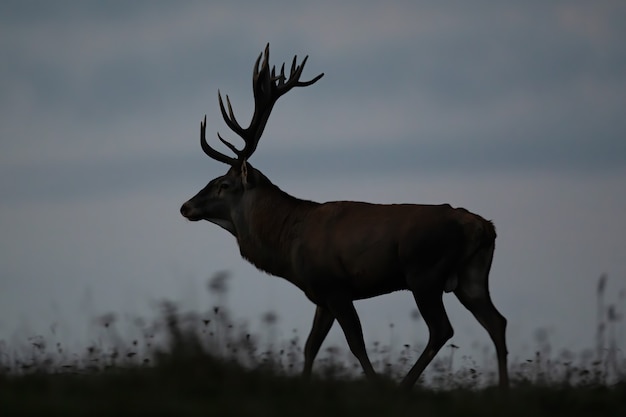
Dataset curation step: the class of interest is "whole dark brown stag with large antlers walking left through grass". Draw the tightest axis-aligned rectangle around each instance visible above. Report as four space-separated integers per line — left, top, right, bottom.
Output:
180 43 509 389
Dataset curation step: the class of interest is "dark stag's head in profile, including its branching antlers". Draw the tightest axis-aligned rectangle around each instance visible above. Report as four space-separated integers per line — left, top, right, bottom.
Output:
180 44 324 237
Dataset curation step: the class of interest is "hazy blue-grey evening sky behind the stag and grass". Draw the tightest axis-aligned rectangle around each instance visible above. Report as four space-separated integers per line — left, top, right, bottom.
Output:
0 0 626 374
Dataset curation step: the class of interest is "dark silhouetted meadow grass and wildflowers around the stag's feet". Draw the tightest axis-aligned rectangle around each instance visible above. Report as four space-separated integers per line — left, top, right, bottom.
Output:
0 276 626 416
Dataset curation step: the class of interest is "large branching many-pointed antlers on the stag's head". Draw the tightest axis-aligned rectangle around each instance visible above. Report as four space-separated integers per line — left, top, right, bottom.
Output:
200 43 324 168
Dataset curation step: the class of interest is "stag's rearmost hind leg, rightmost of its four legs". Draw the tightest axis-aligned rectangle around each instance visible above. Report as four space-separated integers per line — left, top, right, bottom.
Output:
454 245 509 387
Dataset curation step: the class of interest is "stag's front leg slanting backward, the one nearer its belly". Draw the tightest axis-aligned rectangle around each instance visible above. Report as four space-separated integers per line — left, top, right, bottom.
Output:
327 298 376 378
